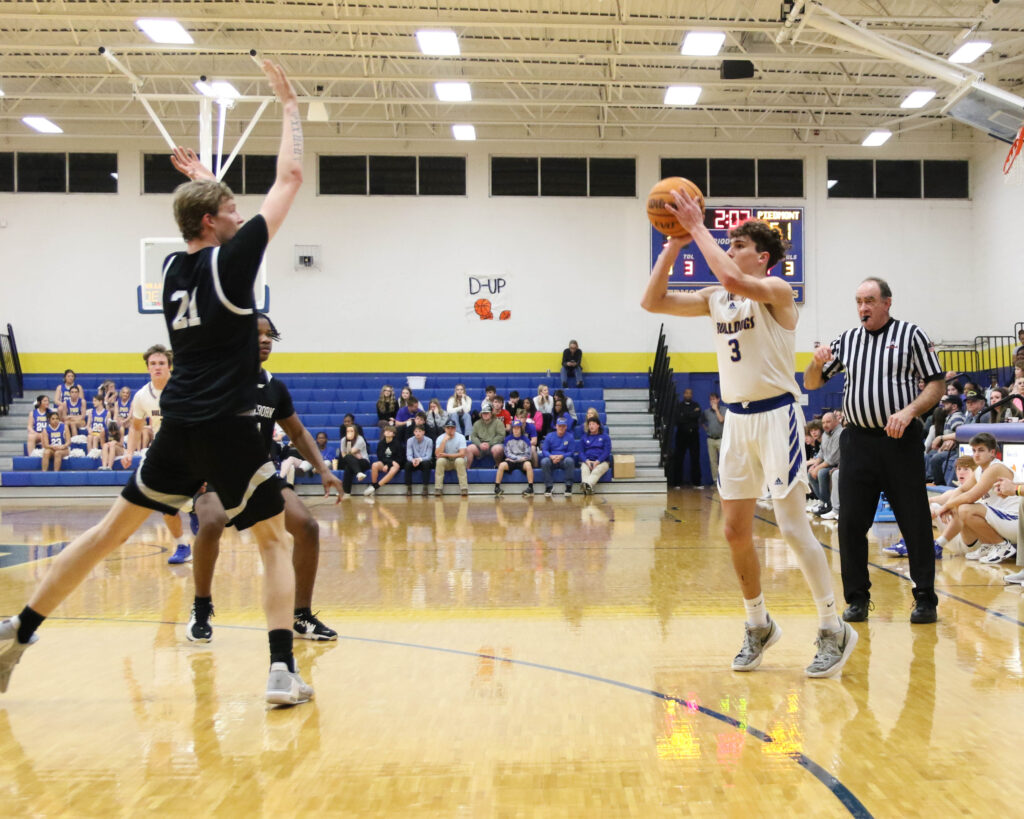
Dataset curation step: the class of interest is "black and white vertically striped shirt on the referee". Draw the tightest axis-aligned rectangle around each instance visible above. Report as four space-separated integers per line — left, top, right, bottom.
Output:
821 318 943 429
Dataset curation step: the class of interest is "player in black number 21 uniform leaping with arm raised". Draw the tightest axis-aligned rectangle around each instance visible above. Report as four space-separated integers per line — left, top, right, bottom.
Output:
0 60 313 704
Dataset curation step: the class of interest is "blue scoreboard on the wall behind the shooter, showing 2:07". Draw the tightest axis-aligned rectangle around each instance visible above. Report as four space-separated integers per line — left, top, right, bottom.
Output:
650 205 805 304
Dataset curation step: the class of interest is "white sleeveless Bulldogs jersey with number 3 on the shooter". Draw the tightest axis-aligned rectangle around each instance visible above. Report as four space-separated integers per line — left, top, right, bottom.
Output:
708 288 800 403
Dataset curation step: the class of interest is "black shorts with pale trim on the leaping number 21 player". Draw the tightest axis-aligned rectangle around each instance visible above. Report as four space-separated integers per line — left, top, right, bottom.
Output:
121 416 285 529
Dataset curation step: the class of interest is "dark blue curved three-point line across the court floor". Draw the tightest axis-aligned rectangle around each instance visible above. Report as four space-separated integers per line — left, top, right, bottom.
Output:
50 616 872 819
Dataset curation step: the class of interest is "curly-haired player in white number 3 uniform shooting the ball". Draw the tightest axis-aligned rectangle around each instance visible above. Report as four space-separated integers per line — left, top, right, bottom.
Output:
641 185 857 677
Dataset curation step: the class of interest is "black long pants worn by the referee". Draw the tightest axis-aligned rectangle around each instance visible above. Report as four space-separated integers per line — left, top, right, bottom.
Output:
839 421 938 605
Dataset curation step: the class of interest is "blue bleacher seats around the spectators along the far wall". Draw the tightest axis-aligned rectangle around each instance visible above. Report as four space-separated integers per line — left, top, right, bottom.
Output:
2 371 647 488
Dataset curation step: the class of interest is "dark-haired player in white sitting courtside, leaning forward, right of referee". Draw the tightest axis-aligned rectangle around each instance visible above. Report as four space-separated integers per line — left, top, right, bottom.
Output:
932 432 1020 563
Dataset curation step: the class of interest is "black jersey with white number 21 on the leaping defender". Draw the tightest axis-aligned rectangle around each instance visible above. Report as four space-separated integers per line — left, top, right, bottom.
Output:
160 216 268 424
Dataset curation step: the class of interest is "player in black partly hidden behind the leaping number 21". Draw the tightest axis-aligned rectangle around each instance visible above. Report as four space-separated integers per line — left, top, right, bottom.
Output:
185 314 342 643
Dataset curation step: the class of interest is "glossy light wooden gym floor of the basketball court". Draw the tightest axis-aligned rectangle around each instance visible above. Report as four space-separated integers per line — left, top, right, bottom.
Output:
0 490 1024 817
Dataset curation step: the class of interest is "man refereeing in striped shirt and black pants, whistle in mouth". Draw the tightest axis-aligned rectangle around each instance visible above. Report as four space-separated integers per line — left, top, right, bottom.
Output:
804 276 944 622
